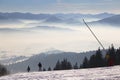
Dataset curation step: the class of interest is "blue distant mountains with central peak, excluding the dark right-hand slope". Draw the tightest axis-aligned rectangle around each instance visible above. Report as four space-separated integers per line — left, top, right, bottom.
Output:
0 12 114 24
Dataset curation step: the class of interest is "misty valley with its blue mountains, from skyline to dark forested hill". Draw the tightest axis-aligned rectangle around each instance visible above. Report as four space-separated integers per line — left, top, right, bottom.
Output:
0 13 120 58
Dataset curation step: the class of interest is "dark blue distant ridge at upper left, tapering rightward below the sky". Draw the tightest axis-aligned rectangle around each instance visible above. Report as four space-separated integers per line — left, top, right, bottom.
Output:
0 12 51 20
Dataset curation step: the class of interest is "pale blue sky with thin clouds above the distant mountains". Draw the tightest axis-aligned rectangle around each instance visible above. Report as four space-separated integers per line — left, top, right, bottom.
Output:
0 0 120 14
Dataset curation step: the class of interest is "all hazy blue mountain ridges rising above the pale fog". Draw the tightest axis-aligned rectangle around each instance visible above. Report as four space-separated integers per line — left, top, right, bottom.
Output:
0 12 120 32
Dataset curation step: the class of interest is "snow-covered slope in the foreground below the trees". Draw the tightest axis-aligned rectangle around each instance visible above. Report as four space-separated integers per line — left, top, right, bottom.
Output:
0 66 120 80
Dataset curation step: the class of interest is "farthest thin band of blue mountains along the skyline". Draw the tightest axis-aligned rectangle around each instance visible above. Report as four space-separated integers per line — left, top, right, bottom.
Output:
0 12 114 20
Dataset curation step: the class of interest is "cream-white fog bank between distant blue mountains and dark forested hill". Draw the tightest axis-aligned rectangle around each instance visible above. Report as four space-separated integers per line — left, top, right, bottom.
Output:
0 20 120 57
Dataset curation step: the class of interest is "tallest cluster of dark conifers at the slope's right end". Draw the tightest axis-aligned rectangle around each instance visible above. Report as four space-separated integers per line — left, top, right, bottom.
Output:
80 45 120 68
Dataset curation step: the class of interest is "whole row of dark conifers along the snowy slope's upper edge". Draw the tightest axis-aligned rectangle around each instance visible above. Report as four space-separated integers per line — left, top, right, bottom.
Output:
28 45 120 72
